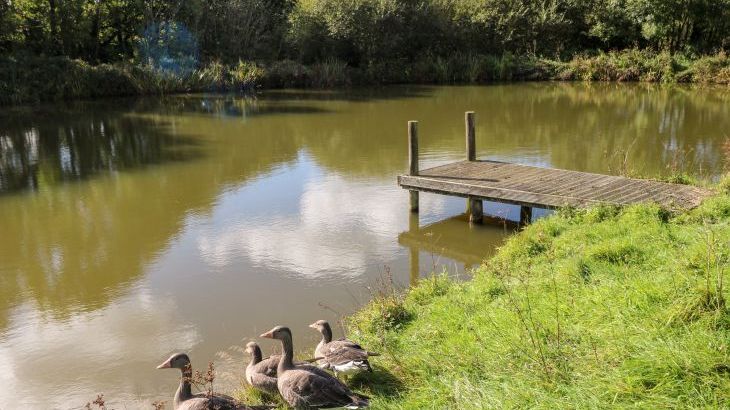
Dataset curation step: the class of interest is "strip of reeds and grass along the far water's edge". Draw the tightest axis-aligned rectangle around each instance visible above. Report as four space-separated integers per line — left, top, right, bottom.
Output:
0 50 730 105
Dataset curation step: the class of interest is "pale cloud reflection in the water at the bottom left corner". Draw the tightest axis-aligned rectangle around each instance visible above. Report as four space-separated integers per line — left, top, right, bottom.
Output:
0 289 200 409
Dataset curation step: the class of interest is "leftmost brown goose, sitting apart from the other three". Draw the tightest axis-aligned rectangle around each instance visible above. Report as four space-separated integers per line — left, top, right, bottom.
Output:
157 353 270 410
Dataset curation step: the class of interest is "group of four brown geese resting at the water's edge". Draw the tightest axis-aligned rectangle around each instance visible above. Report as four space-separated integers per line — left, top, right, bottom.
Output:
157 320 378 410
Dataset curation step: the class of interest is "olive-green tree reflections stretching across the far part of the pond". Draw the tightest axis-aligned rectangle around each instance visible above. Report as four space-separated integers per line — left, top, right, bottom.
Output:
0 84 730 328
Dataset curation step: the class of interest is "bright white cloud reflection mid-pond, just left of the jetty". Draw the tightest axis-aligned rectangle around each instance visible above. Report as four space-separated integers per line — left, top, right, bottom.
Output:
197 167 444 278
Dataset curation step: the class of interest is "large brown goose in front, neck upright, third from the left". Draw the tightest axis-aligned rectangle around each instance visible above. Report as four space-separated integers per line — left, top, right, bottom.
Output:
261 326 368 409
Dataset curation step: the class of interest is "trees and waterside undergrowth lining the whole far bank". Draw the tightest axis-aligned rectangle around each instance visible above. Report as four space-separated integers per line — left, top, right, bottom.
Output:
0 0 730 104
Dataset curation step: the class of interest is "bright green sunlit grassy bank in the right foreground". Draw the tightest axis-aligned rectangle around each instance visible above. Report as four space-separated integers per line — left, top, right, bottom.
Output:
342 179 730 409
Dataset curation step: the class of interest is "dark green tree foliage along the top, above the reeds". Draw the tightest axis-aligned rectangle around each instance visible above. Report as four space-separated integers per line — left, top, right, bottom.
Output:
0 0 730 67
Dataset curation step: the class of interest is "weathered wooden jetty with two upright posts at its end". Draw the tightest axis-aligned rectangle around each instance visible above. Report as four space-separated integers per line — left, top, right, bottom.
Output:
398 112 711 224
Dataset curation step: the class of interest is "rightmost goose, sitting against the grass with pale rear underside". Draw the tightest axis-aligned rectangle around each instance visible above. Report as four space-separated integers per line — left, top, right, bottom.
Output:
309 320 379 376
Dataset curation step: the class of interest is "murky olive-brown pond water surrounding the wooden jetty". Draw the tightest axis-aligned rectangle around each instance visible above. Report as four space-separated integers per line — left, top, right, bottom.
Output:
0 83 730 409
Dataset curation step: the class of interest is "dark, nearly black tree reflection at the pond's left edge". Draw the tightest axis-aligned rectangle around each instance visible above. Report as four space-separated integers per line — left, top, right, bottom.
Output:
0 108 199 193
